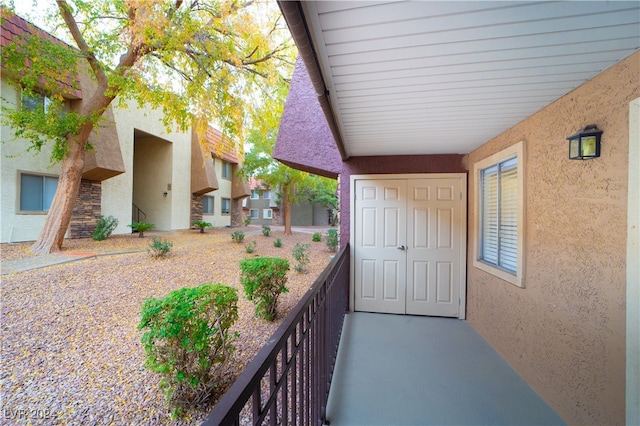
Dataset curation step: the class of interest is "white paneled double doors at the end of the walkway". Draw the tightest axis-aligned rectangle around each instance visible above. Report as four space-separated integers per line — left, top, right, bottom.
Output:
352 175 466 318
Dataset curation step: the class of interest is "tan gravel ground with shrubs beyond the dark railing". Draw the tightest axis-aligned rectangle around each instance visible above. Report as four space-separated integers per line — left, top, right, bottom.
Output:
0 227 333 425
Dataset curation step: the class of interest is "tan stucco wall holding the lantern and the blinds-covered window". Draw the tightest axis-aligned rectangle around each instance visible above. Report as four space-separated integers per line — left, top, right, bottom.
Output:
467 52 640 424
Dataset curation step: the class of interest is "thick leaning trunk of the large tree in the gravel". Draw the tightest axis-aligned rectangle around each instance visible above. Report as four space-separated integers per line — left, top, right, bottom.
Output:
31 129 91 254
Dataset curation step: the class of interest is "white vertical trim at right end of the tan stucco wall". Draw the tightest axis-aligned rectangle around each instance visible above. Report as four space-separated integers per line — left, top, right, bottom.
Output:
626 98 640 425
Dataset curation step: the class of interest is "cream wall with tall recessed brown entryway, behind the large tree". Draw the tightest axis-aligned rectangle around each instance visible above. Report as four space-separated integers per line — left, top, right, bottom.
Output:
102 102 191 234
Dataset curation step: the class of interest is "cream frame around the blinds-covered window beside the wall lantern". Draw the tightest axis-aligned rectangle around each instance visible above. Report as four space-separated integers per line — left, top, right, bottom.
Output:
473 141 526 288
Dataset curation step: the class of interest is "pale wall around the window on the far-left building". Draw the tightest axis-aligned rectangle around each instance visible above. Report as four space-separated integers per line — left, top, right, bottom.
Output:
0 74 60 243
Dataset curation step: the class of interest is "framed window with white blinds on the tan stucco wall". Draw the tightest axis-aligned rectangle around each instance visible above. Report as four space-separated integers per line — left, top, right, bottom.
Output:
474 142 524 287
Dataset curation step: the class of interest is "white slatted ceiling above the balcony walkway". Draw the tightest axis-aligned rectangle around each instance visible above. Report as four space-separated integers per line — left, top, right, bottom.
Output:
296 1 640 156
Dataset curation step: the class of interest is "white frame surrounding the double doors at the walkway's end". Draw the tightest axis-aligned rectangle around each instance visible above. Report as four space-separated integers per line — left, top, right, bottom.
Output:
349 173 468 319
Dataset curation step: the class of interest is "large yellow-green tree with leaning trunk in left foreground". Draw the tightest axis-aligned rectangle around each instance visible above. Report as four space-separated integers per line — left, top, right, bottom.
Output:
2 0 292 254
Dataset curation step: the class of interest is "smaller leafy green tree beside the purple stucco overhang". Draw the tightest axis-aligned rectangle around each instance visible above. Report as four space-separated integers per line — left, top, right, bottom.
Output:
240 80 338 235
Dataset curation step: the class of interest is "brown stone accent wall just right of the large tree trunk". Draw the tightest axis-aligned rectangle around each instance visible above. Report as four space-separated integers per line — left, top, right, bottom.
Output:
69 179 102 238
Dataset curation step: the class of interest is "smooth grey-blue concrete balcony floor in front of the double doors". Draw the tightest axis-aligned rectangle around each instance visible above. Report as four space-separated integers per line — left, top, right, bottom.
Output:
327 312 564 426
